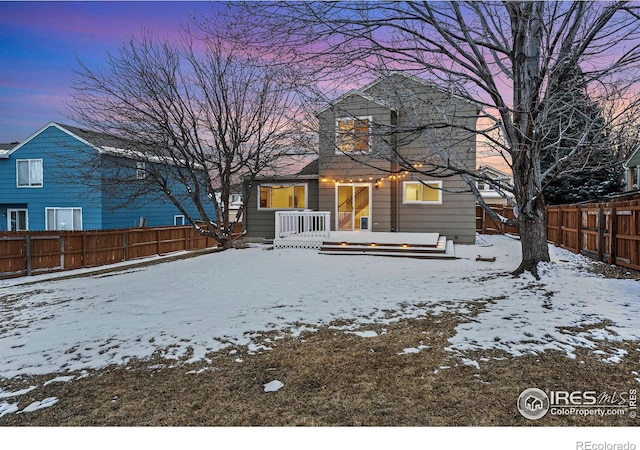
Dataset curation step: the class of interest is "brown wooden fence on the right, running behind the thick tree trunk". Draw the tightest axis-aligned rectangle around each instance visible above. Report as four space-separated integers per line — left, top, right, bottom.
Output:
476 199 640 270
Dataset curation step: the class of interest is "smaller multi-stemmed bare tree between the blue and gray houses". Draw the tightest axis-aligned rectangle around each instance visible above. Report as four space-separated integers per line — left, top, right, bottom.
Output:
68 22 308 248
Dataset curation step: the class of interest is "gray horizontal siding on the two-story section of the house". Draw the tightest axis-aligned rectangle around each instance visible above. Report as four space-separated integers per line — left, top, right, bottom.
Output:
318 75 477 243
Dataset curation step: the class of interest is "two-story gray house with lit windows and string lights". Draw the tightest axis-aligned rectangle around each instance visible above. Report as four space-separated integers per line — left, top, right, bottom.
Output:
244 72 478 243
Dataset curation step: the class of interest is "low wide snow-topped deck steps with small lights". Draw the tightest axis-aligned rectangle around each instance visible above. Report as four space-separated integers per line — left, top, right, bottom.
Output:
320 232 455 259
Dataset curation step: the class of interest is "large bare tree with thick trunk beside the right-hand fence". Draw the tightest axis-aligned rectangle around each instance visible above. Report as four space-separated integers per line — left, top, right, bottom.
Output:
238 1 640 274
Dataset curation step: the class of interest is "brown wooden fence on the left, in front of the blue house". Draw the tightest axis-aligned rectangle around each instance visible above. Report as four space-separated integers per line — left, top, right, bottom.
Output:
0 226 230 278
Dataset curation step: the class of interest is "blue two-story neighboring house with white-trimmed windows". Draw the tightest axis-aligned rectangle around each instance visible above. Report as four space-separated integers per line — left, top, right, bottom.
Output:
0 122 215 231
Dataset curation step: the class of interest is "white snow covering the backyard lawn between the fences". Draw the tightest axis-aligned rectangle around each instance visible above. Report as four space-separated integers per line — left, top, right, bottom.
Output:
0 236 640 415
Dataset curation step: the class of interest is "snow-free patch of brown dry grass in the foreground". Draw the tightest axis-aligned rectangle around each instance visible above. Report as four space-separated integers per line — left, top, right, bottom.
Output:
0 305 640 426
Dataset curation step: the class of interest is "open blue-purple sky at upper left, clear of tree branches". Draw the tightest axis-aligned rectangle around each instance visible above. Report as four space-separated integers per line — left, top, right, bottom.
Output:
0 1 215 143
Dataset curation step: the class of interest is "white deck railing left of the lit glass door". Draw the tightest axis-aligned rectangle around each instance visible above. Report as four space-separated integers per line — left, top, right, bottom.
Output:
274 211 331 248
